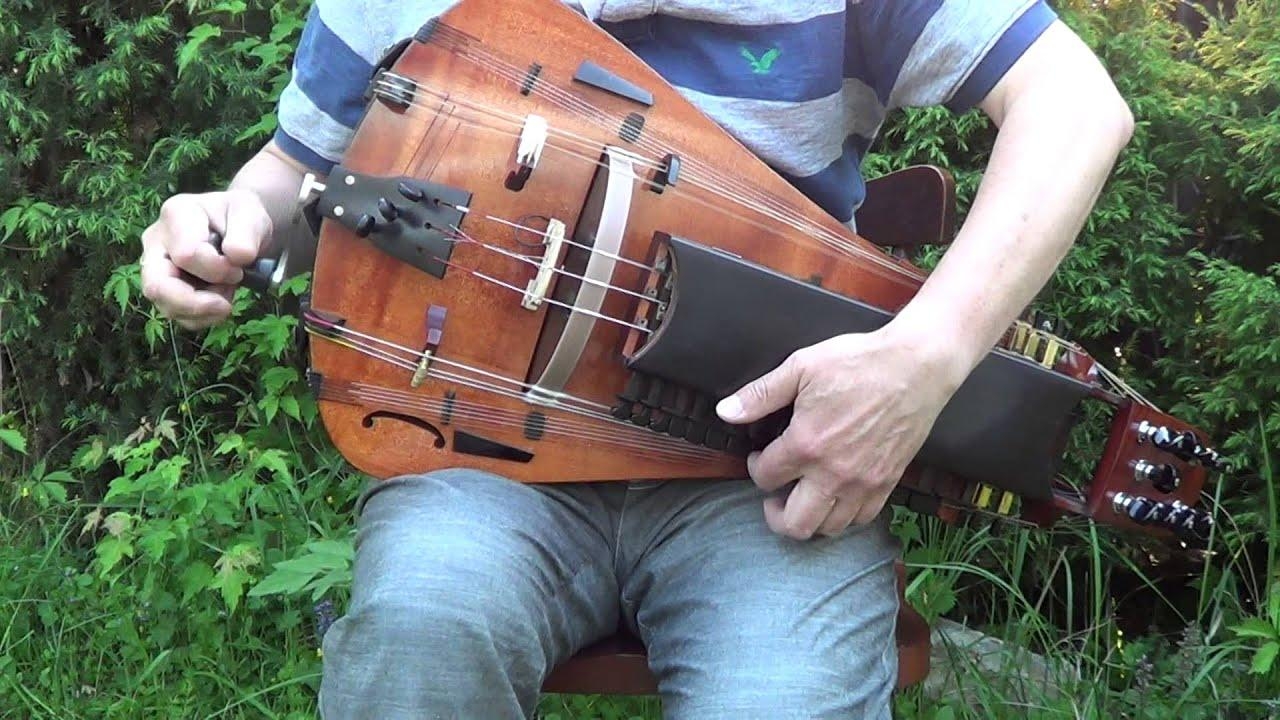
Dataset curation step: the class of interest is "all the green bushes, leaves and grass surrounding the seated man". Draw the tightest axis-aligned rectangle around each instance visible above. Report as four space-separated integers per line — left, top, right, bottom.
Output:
0 0 1280 720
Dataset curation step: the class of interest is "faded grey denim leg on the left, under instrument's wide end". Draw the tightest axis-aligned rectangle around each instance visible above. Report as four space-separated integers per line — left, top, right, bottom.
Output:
321 470 617 720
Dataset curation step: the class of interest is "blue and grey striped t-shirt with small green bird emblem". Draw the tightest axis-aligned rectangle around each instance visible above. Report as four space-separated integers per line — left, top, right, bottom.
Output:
275 0 1056 222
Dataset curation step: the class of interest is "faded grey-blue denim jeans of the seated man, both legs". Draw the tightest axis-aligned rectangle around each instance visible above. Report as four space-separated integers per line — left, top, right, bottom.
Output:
320 470 899 720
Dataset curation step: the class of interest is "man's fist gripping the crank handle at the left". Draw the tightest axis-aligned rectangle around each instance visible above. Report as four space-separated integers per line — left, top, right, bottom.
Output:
141 190 273 329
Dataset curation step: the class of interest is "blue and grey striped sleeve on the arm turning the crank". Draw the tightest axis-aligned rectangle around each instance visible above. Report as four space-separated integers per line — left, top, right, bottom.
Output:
275 3 374 173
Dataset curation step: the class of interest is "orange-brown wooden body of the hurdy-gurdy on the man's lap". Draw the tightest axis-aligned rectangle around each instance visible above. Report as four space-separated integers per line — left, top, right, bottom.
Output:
299 0 1204 538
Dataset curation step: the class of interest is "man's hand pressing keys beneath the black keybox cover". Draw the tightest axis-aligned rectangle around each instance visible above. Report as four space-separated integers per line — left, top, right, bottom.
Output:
716 327 963 539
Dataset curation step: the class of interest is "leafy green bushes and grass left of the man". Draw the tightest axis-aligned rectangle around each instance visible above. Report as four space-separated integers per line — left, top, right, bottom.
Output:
0 0 325 717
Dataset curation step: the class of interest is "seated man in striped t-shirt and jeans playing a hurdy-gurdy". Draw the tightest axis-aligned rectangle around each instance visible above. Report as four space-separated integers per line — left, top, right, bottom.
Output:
142 0 1133 719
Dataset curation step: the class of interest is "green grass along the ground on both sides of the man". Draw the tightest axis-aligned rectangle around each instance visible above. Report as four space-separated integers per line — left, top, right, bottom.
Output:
0 420 1280 720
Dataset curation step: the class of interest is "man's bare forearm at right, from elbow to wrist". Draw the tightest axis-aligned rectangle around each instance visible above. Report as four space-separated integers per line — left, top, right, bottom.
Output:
892 47 1132 382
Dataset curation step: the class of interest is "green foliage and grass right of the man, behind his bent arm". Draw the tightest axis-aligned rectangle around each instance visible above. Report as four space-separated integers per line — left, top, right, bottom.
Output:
869 0 1280 717
